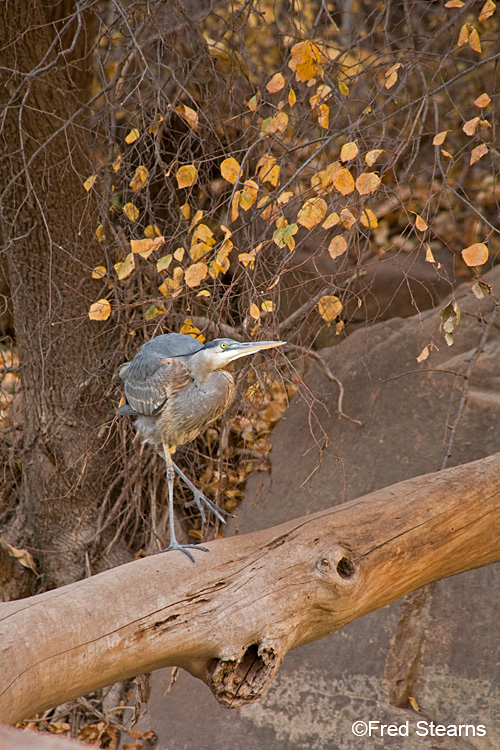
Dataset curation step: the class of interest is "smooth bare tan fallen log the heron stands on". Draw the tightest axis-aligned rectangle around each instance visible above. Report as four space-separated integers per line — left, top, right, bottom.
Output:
0 454 500 723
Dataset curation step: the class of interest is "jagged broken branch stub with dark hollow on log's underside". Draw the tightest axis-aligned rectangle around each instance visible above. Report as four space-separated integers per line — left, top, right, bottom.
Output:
206 643 282 708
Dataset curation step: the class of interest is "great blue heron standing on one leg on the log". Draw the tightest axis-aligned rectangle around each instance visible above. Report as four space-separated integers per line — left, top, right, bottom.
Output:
117 333 285 562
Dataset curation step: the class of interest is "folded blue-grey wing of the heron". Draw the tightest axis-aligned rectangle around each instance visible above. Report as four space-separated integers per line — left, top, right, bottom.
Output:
125 352 192 416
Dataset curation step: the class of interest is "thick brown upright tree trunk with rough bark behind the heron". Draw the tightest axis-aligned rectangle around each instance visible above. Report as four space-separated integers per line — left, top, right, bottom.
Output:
0 0 120 585
